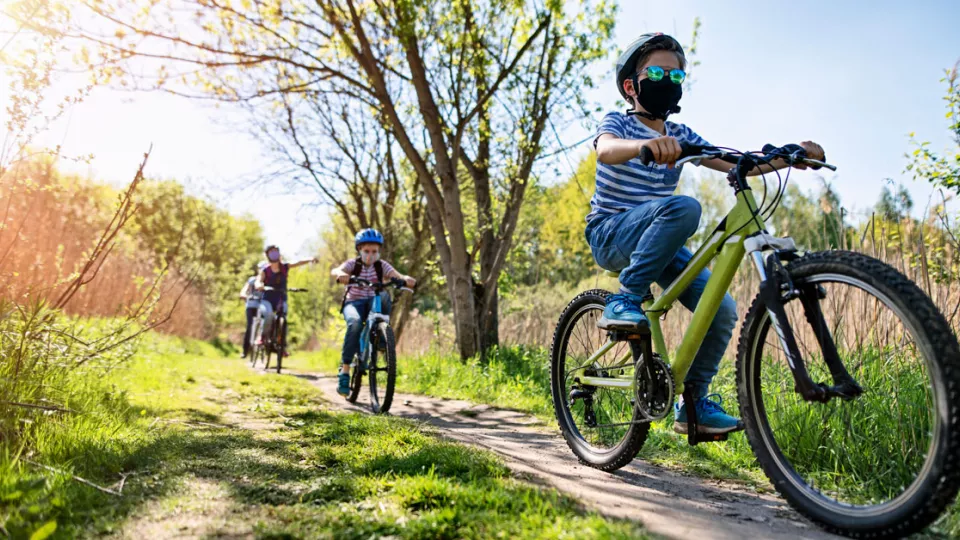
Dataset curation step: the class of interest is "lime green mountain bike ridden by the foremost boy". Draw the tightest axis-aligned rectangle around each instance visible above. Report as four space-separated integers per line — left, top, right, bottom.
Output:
551 141 960 538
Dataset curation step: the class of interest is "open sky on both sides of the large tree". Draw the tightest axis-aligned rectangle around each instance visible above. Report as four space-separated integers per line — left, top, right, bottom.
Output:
9 0 960 251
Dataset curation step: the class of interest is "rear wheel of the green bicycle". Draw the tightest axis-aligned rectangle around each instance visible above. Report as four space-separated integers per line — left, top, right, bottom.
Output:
550 290 650 471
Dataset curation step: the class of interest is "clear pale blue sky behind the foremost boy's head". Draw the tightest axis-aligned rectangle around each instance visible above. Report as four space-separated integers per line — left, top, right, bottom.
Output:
598 1 960 223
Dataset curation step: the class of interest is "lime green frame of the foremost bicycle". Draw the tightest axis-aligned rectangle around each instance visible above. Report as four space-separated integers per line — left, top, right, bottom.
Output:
579 185 766 394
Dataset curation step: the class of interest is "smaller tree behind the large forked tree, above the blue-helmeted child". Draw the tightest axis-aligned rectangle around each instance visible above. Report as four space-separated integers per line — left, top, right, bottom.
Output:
253 92 436 341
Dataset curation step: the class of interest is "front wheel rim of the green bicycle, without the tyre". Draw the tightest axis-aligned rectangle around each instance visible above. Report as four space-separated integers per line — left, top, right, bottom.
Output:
748 273 944 518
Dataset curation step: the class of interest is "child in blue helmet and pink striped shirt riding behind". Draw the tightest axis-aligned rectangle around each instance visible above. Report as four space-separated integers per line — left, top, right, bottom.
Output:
330 229 417 396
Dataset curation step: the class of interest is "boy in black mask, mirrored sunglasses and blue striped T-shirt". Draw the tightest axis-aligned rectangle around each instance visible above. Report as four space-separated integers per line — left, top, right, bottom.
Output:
585 33 824 433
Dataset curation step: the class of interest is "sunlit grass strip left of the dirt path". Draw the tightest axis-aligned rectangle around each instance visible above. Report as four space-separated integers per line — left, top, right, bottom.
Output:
0 335 644 538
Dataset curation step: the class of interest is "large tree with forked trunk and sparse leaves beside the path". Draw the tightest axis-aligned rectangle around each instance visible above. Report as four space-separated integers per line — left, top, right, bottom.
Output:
47 0 615 358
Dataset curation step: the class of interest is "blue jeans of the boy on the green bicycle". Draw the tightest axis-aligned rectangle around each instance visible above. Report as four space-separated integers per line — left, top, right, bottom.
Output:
586 195 737 397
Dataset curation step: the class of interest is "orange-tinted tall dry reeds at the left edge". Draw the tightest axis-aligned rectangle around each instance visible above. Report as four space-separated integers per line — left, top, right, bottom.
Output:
0 154 205 337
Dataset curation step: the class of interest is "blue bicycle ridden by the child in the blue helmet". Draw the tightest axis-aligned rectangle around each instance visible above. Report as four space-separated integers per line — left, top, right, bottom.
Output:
347 276 414 414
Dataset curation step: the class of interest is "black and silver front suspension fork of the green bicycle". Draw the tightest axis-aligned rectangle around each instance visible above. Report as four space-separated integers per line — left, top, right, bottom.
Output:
751 251 863 403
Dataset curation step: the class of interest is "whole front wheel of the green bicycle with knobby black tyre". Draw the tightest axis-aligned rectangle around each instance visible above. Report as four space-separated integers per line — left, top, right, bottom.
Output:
737 251 960 538
